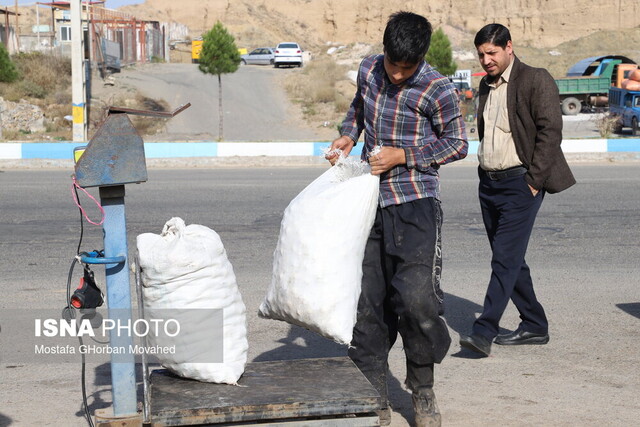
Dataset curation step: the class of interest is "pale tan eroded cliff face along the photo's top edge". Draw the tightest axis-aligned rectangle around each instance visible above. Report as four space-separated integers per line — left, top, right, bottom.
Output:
121 0 640 49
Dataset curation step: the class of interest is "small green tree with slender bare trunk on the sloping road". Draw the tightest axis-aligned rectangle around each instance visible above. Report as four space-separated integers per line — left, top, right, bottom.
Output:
198 21 240 141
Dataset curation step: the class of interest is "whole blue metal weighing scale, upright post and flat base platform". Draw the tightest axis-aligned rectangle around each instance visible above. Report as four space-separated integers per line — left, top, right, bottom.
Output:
75 104 381 427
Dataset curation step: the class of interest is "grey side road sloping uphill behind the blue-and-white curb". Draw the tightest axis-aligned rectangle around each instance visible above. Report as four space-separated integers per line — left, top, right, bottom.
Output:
107 64 324 141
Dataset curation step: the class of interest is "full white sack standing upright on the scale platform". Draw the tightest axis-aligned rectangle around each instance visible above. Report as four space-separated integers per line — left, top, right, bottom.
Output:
137 218 248 384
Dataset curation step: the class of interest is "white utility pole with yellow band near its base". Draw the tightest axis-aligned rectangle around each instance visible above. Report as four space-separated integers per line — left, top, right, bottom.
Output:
70 0 87 142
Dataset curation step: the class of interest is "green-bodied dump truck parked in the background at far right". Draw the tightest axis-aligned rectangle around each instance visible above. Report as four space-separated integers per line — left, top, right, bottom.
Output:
556 55 638 116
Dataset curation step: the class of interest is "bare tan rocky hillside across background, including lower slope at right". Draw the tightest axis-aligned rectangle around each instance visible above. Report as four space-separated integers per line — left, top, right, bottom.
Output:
7 0 640 77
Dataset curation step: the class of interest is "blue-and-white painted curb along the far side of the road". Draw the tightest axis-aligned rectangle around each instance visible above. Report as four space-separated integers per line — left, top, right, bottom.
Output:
0 138 640 169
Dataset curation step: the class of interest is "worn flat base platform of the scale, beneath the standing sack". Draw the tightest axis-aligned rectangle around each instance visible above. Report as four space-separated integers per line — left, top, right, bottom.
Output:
150 357 380 427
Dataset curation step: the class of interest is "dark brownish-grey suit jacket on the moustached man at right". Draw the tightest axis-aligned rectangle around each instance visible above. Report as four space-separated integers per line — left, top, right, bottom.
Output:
478 57 576 193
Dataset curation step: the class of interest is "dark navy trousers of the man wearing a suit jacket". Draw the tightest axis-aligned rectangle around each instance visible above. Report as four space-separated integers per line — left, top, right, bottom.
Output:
473 169 549 339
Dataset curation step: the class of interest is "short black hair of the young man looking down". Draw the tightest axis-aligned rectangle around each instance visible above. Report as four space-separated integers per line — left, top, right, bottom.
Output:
382 12 432 64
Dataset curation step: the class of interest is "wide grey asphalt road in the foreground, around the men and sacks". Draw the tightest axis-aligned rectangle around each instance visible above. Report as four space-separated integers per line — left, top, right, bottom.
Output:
0 163 640 426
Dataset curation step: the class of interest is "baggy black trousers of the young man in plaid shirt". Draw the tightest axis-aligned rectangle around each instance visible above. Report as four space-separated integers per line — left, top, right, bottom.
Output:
349 198 451 402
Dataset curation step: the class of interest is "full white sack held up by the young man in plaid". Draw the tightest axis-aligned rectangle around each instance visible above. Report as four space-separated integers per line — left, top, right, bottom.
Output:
258 158 380 344
